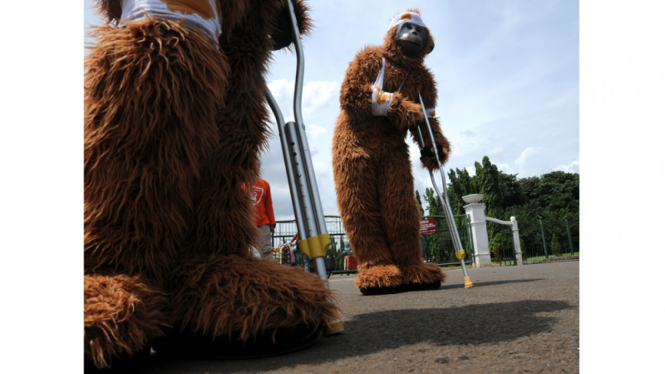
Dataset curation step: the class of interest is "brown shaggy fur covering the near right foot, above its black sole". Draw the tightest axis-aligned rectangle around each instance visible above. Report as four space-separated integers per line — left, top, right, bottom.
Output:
173 255 336 339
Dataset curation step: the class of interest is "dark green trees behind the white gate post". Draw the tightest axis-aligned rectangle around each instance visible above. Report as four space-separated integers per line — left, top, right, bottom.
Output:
416 156 579 259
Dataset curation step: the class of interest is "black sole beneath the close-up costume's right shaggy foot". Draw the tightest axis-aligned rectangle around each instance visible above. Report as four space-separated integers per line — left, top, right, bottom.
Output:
153 324 323 359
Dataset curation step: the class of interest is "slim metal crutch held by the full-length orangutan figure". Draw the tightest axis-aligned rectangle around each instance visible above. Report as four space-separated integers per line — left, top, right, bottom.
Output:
417 92 473 288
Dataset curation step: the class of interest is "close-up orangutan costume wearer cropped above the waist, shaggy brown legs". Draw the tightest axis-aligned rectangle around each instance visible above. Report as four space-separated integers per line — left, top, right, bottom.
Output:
84 0 337 369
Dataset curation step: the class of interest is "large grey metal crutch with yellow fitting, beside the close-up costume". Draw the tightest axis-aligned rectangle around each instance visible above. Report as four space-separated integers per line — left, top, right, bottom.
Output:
266 1 344 335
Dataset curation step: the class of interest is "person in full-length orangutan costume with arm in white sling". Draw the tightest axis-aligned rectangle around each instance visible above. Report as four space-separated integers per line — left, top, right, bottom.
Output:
333 10 450 295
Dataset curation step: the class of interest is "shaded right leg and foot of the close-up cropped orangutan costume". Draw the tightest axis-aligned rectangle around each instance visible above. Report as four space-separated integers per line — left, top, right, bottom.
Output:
160 85 338 358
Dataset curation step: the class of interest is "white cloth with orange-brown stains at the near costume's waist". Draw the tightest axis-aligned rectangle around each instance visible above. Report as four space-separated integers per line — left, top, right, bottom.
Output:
120 0 222 44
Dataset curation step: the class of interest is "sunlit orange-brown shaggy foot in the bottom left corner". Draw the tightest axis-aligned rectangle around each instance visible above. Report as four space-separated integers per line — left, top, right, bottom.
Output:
84 274 168 369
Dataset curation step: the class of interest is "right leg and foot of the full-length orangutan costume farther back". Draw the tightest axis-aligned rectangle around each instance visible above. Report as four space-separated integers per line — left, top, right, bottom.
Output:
378 140 445 290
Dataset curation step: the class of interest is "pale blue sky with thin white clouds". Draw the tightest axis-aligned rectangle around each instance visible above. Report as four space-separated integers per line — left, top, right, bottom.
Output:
85 0 579 220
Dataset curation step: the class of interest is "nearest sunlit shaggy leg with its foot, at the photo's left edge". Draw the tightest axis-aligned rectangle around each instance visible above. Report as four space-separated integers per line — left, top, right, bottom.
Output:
84 20 225 367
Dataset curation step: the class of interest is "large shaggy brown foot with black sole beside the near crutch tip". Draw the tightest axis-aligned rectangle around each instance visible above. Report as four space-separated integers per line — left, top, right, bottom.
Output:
161 255 339 358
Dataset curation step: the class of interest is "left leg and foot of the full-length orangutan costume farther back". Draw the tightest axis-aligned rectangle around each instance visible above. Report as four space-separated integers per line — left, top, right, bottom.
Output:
333 122 402 291
